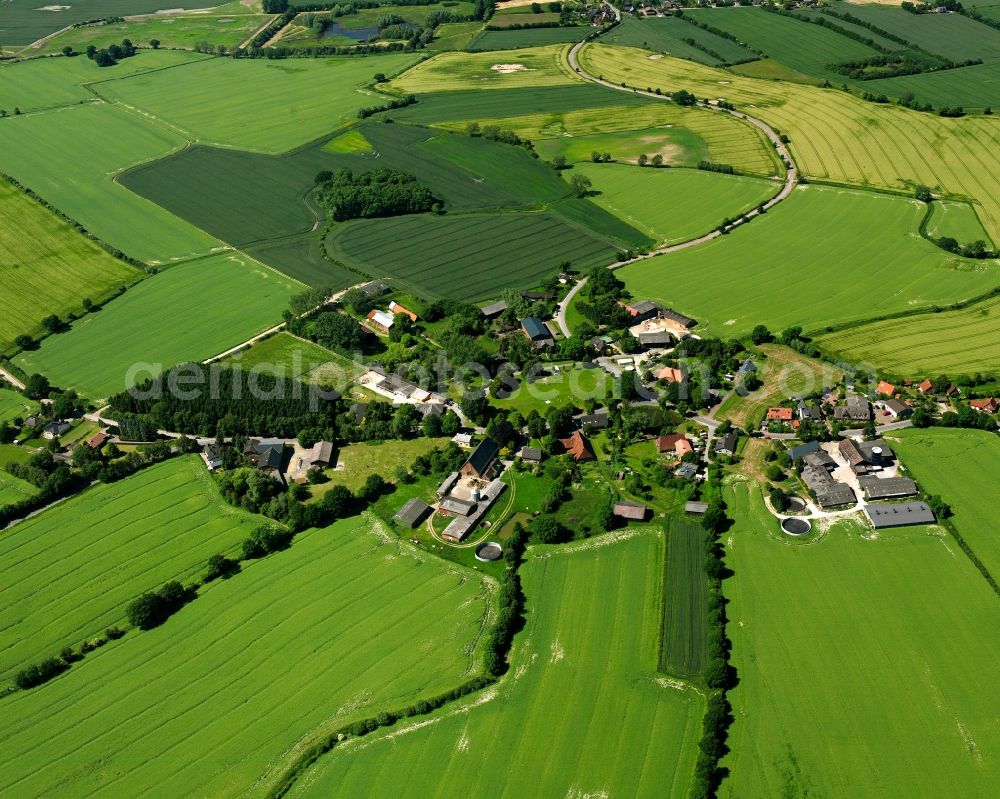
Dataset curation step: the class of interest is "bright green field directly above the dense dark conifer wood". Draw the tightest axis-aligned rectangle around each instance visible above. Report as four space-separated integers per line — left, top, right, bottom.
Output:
16 254 302 399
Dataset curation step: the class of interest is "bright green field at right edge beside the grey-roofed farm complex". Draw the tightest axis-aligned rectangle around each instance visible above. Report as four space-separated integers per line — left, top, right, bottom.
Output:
892 428 1000 579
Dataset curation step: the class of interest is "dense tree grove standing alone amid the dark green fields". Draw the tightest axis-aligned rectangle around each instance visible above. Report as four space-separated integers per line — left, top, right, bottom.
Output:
316 168 438 222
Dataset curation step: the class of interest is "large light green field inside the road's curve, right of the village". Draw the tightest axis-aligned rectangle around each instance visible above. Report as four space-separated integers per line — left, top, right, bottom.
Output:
618 186 1000 337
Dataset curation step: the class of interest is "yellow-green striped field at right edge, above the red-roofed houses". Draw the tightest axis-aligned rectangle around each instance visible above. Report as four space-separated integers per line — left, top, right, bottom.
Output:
817 297 1000 377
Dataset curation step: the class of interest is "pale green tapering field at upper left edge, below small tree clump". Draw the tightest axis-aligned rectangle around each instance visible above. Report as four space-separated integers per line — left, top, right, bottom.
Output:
0 47 206 114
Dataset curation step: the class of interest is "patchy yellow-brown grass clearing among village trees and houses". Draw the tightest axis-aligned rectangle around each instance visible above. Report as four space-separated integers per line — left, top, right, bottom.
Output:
716 344 844 430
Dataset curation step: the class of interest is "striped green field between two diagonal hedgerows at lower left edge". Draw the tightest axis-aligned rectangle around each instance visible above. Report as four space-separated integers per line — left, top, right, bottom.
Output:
0 456 265 683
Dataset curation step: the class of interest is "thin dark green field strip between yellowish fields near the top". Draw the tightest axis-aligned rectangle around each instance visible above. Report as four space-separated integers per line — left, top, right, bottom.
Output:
392 84 654 125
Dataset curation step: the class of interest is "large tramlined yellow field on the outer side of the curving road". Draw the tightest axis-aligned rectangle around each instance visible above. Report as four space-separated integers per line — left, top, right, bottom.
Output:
580 44 1000 239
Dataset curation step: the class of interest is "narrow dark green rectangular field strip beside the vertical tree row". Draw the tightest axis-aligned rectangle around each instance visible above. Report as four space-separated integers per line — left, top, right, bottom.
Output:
660 519 708 677
